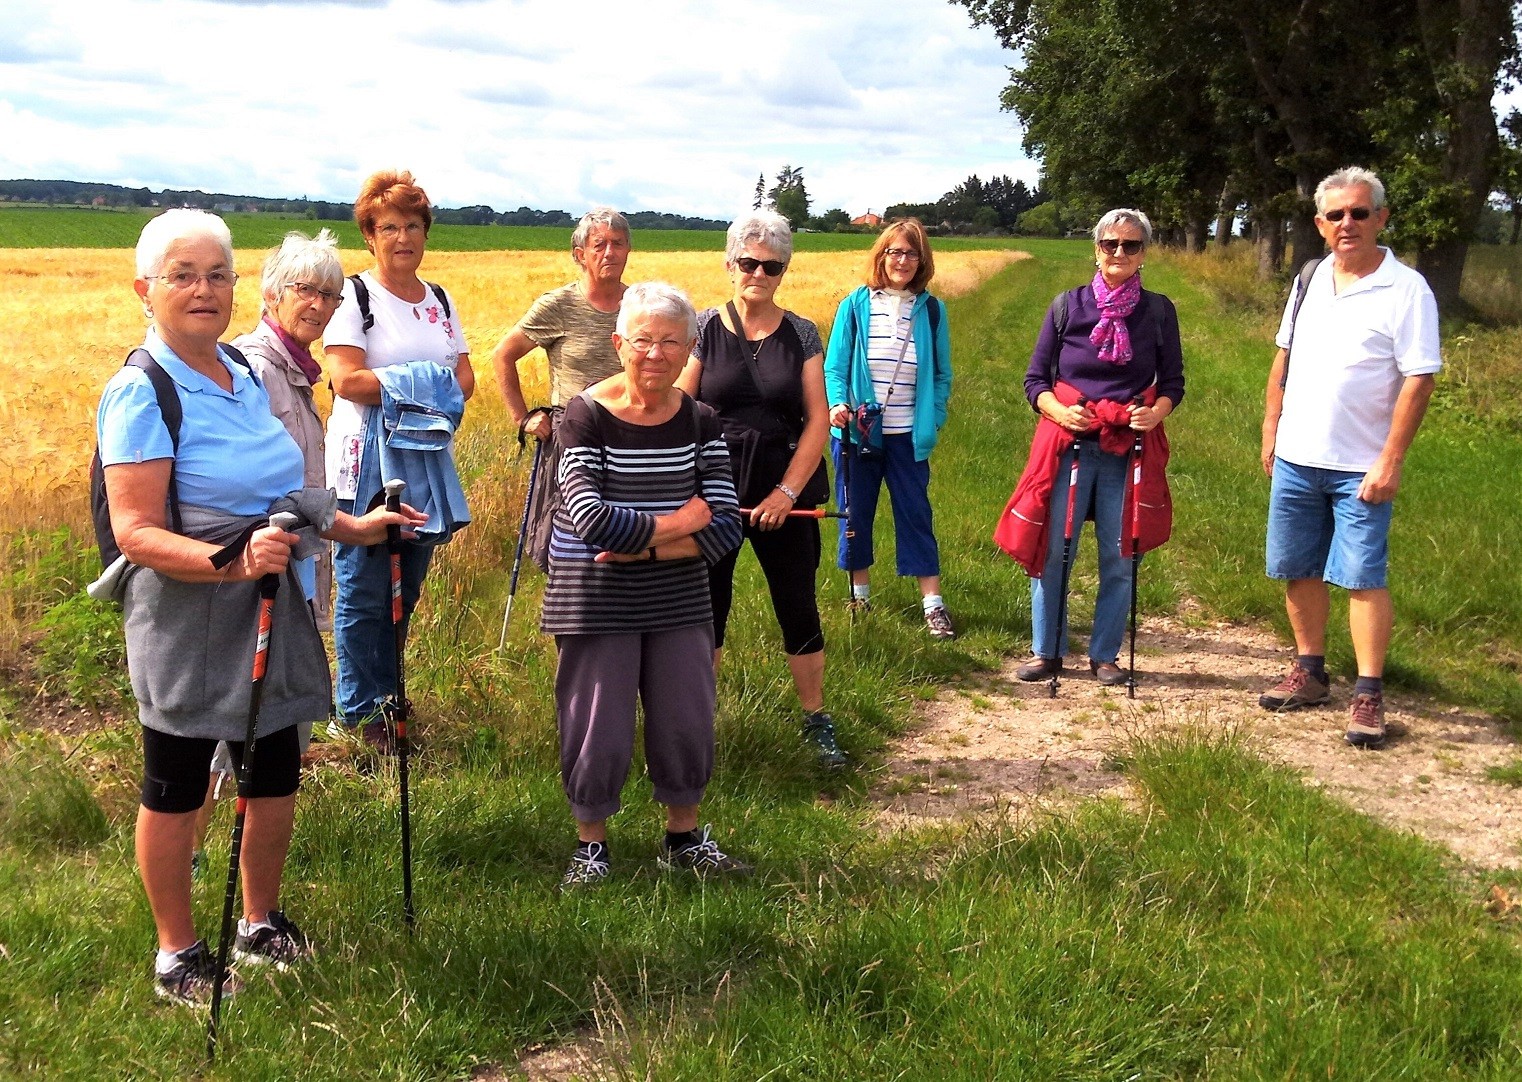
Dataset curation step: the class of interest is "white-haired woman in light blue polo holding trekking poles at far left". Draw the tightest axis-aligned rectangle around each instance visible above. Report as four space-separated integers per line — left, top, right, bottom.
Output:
90 210 417 1001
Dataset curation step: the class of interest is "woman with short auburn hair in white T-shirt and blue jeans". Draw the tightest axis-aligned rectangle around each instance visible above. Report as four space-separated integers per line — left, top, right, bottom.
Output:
323 170 475 753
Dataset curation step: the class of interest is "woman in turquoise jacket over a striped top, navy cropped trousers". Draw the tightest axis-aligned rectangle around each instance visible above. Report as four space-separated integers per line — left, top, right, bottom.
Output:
825 218 956 639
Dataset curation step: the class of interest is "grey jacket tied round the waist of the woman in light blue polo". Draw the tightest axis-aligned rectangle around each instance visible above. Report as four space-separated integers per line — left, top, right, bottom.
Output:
90 488 335 740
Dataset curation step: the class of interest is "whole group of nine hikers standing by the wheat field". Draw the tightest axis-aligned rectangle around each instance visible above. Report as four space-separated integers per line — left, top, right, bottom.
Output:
91 167 1440 1003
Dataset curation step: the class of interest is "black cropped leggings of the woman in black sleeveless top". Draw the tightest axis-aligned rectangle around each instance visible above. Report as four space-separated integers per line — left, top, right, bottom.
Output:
708 519 825 657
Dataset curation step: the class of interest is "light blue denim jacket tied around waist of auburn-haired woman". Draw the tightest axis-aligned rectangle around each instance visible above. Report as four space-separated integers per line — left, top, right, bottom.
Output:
355 361 470 545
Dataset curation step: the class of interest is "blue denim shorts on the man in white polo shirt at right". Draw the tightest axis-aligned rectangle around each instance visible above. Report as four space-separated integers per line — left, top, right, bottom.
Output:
1268 458 1394 590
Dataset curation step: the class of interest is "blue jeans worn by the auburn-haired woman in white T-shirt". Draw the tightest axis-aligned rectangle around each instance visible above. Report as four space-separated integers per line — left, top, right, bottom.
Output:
333 499 434 726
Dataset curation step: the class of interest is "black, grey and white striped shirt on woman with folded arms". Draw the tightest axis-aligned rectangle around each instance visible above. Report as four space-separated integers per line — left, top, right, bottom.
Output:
540 394 741 635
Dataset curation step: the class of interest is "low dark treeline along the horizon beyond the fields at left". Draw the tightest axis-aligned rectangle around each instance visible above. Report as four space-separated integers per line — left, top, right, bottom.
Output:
0 180 729 230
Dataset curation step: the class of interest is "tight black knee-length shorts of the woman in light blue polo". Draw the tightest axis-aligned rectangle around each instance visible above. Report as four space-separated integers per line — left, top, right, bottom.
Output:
142 724 301 814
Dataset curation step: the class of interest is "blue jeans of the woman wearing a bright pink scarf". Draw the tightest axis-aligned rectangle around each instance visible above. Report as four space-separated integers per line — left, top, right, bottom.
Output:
1030 440 1131 662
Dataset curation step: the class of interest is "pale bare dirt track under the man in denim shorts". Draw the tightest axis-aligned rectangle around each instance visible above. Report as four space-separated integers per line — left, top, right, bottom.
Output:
877 608 1522 867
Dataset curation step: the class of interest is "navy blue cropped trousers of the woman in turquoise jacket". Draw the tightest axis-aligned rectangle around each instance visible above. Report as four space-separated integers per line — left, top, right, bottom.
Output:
829 432 941 578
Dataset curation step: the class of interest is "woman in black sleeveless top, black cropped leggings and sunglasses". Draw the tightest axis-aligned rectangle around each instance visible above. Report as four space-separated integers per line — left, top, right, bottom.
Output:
677 212 846 769
